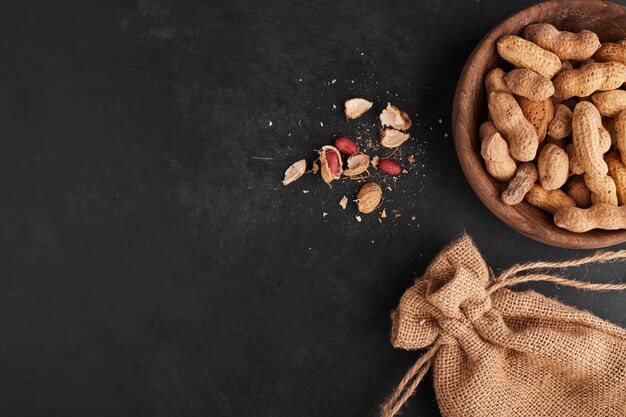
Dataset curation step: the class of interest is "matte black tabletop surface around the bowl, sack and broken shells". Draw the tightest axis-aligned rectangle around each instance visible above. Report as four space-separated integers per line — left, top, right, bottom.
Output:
0 0 626 417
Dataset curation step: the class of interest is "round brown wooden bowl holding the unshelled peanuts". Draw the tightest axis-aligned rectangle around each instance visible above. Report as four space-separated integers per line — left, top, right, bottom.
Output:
452 0 626 249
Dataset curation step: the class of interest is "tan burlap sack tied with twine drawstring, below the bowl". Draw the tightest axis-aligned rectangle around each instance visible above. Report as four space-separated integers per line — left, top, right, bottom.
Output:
382 236 626 417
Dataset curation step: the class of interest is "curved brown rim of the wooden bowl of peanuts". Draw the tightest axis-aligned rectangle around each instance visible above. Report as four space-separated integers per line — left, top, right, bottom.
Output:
452 0 626 249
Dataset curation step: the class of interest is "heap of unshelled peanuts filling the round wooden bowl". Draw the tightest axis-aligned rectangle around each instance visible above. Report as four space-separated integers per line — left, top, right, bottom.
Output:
479 23 626 233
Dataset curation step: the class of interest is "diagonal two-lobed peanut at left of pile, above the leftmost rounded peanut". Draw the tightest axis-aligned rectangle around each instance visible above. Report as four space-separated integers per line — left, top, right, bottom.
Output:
489 92 539 162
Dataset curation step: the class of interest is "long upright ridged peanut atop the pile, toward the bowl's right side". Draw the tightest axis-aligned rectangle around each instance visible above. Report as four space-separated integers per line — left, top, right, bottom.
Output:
572 101 609 178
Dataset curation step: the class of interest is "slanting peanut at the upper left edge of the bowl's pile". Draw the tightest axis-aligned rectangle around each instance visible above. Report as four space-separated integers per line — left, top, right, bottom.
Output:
497 35 561 80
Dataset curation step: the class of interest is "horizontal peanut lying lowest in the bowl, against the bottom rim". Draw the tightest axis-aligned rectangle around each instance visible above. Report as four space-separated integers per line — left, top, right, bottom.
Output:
554 204 626 233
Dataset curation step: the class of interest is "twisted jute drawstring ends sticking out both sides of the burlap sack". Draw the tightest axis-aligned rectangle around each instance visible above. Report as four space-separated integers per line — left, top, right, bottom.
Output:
380 250 626 417
